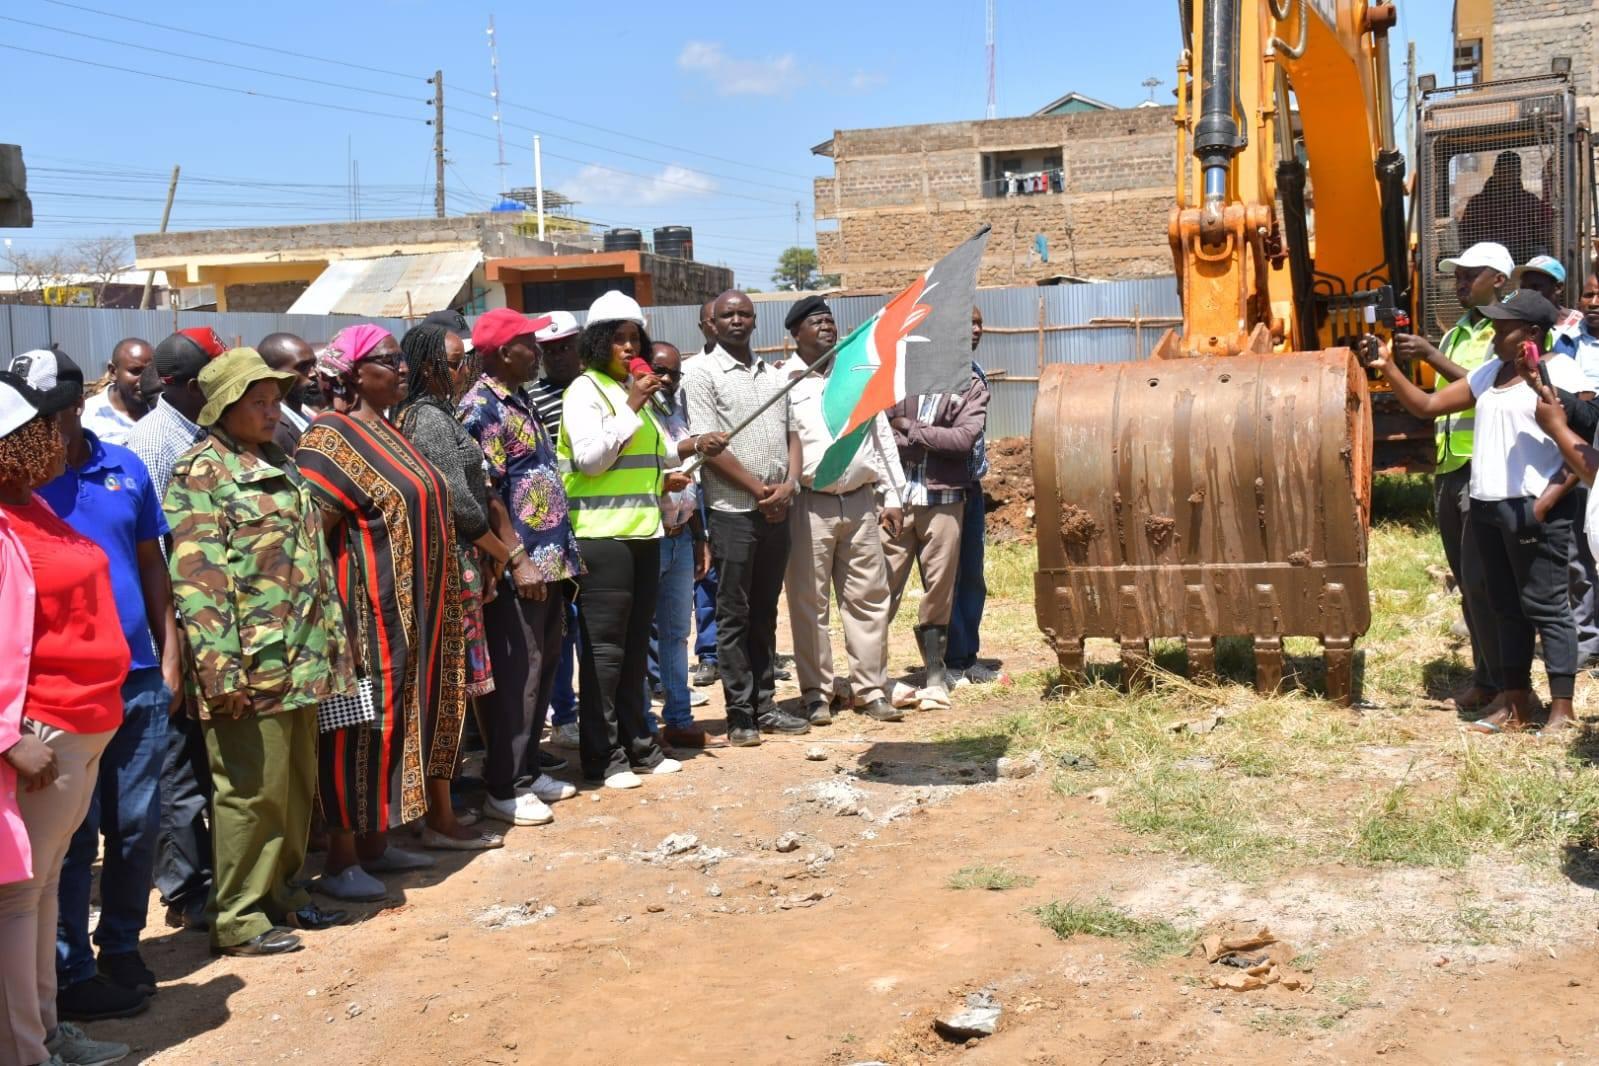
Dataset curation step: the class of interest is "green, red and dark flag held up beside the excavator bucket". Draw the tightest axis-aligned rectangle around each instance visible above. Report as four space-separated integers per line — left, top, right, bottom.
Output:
815 225 988 489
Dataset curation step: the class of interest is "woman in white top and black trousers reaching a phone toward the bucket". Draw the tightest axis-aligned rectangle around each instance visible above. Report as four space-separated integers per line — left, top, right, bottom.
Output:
1372 289 1586 734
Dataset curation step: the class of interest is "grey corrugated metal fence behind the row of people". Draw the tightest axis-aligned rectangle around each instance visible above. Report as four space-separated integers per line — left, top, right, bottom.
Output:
0 278 1182 436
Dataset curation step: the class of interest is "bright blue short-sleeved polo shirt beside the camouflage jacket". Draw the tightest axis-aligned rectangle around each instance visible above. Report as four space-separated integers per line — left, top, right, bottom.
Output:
37 430 166 670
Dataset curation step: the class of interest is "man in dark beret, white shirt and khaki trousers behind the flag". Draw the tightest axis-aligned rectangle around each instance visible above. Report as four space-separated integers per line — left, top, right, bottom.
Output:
777 296 905 724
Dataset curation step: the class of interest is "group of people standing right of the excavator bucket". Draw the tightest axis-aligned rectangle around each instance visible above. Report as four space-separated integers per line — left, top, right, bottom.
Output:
1375 241 1599 734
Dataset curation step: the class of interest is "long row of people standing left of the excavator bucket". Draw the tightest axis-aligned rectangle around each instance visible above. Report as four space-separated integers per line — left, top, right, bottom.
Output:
0 291 991 1066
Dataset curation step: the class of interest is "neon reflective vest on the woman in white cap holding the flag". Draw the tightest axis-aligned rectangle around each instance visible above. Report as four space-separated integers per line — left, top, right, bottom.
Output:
555 371 667 539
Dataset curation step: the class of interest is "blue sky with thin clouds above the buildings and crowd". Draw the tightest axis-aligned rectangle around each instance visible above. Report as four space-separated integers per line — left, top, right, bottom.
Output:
0 0 1452 288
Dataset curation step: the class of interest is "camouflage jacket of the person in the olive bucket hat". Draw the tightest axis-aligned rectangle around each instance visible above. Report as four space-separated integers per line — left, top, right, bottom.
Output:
165 430 355 718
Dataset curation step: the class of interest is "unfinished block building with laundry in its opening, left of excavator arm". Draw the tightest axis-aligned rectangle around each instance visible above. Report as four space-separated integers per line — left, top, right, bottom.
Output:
812 94 1174 291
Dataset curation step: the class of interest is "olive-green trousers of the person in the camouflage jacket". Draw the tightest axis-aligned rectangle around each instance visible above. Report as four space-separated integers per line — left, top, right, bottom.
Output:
205 705 317 948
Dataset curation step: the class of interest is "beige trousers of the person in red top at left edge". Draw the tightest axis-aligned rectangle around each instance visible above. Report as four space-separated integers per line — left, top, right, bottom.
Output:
0 722 117 1066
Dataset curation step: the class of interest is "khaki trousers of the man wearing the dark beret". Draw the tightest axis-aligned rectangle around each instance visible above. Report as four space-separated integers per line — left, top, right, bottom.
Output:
787 486 889 705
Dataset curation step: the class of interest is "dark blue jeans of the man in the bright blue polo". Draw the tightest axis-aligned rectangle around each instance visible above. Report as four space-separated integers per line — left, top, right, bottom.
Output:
56 666 171 988
